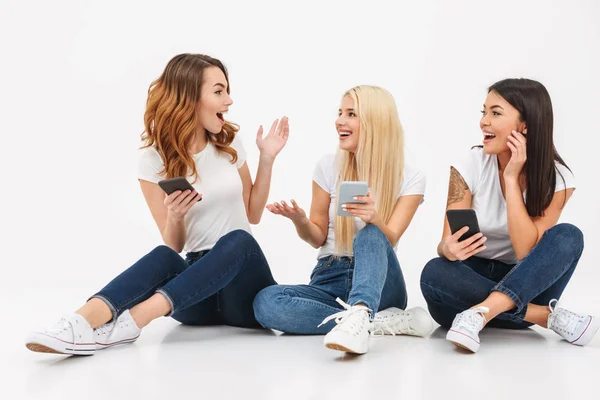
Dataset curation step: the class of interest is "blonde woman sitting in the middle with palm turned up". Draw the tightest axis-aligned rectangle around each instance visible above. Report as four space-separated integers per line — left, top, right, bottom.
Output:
254 86 432 354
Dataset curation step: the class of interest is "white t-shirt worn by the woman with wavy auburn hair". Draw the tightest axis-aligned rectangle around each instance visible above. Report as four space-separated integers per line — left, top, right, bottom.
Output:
137 135 251 252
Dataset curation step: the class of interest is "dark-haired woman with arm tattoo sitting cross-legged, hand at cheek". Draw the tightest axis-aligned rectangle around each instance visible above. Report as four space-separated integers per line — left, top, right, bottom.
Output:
421 79 600 352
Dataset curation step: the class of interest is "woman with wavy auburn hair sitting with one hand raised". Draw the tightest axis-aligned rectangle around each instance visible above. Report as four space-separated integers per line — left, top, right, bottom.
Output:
26 54 289 355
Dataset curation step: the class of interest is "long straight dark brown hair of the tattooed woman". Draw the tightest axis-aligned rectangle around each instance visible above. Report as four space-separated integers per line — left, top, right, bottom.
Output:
488 78 569 217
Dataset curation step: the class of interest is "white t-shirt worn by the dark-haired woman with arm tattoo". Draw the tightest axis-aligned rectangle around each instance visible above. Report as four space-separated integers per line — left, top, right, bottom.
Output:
452 147 575 264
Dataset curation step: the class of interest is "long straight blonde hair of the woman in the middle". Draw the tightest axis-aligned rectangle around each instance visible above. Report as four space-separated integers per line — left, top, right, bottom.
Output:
335 85 404 254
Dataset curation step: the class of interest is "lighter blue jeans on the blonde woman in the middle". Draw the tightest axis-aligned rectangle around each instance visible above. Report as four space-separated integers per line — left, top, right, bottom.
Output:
254 225 407 335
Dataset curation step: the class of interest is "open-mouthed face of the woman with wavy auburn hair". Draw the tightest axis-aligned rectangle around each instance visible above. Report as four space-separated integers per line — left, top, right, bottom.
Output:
197 67 233 133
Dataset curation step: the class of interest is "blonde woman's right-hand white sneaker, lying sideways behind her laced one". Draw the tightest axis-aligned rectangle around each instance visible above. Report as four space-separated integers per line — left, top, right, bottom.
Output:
371 307 433 337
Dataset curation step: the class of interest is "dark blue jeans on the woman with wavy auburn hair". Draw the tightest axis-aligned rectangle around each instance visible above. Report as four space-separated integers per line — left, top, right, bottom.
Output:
92 230 277 328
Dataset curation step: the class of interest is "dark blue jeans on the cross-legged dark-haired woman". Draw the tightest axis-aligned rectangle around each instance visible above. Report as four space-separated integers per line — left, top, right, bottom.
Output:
421 224 583 329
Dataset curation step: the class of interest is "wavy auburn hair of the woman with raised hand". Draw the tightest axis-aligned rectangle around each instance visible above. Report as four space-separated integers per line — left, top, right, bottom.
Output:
142 54 239 179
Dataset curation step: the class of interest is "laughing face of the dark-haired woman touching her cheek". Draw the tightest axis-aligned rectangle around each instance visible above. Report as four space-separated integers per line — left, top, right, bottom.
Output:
479 91 527 154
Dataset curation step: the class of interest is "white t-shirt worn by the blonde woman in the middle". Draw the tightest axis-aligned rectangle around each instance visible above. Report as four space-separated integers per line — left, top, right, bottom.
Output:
313 154 426 258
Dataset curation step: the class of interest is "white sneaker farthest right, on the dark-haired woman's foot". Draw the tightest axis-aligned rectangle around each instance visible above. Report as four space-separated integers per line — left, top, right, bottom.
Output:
548 299 600 346
